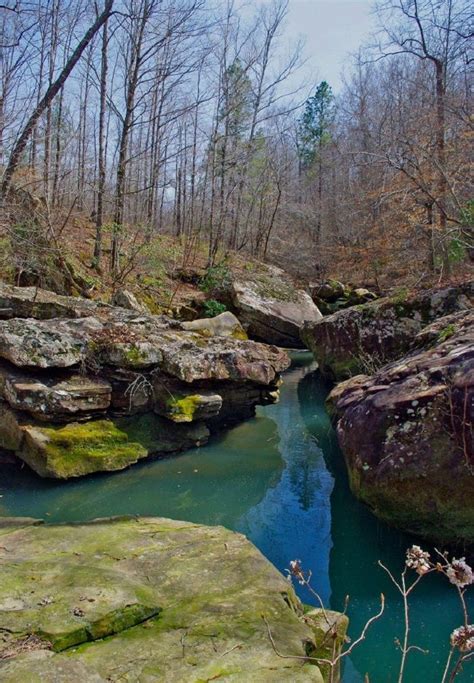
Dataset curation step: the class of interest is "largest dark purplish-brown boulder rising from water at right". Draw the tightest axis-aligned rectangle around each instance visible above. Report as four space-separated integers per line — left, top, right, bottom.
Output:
329 310 474 546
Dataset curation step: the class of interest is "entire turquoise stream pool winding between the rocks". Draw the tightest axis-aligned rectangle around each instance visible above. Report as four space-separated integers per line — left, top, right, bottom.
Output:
0 353 474 683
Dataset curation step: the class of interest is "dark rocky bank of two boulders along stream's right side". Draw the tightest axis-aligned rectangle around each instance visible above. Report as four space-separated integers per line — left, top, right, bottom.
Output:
302 282 474 549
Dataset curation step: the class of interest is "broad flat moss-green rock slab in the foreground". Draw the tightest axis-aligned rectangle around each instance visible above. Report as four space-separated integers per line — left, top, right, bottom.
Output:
0 518 347 683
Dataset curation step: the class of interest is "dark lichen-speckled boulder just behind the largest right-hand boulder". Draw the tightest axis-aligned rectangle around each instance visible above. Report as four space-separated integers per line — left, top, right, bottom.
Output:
301 282 474 380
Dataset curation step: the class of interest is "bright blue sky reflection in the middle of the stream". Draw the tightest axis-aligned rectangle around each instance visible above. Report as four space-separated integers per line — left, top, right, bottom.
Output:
237 358 333 601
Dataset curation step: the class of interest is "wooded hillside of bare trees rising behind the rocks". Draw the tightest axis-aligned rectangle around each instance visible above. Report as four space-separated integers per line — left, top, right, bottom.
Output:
0 0 473 298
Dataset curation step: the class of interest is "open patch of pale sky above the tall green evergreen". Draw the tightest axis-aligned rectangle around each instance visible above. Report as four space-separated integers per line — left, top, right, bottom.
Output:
286 0 375 92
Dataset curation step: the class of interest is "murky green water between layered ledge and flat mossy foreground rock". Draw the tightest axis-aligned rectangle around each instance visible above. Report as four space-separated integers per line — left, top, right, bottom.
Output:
0 416 283 527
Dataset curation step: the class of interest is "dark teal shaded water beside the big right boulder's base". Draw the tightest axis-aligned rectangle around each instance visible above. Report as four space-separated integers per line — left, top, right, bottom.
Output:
298 366 472 683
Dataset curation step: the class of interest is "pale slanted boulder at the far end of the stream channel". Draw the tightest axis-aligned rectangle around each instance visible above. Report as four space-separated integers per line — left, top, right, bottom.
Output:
231 267 322 348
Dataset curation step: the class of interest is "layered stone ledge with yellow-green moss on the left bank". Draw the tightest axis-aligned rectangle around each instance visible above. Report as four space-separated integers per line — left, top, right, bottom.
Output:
0 286 289 477
